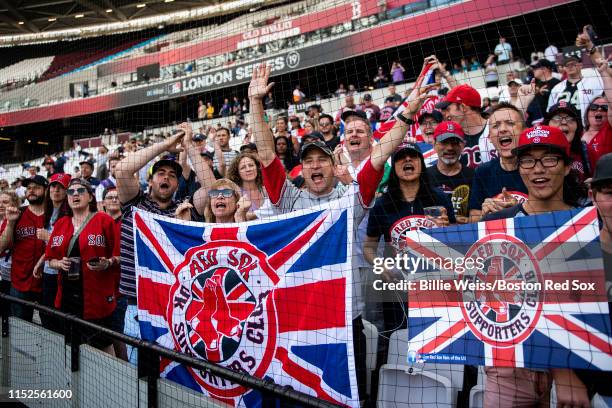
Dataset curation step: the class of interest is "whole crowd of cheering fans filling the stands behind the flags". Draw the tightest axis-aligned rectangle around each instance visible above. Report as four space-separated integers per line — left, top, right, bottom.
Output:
0 27 612 407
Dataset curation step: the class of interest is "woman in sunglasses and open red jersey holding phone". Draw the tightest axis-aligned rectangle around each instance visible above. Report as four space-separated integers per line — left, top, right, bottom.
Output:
45 178 119 354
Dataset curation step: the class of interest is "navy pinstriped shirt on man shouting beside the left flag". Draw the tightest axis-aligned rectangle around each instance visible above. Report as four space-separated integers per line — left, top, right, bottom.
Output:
119 191 179 298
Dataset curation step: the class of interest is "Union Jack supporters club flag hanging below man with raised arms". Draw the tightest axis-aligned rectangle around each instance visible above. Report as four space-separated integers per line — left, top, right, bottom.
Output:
134 203 359 407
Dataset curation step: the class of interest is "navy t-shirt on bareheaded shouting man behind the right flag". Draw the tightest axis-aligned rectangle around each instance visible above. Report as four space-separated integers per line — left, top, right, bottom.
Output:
469 158 527 211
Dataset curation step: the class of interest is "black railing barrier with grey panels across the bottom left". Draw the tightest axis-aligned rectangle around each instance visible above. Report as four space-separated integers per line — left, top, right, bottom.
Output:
0 294 336 408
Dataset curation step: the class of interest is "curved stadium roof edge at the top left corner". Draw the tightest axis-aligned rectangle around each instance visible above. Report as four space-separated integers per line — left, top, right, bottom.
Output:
0 0 281 43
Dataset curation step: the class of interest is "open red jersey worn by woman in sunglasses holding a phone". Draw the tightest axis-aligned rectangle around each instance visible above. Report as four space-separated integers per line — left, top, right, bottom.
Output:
45 212 120 319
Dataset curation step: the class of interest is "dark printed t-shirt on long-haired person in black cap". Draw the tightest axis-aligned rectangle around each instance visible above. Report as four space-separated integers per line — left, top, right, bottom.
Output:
367 188 456 250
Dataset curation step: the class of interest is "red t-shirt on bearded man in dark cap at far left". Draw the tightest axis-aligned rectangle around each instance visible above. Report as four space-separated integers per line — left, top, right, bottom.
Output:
11 207 45 292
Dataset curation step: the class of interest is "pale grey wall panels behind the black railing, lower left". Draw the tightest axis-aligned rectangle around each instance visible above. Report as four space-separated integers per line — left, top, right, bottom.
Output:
0 318 224 408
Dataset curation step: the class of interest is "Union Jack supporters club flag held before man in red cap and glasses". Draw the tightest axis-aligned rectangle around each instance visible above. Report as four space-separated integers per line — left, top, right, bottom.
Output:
406 207 612 370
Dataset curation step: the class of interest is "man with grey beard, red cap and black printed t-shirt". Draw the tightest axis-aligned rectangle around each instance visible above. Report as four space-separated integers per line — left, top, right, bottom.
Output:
427 121 474 223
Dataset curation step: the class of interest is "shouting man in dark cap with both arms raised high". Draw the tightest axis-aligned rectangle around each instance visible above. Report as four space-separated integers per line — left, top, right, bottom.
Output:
249 65 418 400
